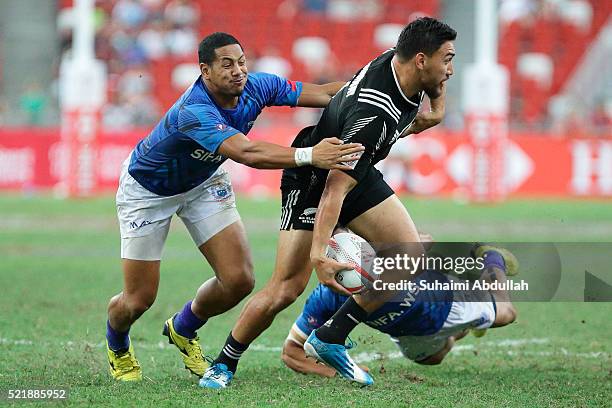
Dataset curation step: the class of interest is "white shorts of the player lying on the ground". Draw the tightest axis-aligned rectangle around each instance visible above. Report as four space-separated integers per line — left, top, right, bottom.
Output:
391 301 495 361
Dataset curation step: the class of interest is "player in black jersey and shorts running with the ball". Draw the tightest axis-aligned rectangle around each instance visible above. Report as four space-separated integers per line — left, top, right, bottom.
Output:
200 17 456 388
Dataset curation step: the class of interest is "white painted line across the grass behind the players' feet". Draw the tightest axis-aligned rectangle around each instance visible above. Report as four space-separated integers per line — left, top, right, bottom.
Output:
0 337 612 363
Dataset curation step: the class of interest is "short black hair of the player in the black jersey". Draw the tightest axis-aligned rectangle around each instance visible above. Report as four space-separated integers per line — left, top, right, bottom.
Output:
395 17 457 60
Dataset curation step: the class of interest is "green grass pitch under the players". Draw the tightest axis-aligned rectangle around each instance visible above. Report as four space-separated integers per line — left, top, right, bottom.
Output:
0 195 612 407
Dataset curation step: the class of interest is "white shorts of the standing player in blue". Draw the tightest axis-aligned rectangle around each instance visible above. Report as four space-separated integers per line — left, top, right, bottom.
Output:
117 158 240 261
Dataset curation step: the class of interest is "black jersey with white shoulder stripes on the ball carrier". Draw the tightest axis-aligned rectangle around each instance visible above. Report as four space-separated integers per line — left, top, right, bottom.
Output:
292 49 425 181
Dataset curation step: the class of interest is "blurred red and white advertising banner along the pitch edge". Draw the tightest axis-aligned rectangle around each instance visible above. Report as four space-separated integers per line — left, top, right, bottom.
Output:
0 128 612 198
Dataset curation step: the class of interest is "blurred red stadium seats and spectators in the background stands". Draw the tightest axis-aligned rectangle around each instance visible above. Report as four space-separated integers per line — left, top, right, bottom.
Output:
7 0 612 135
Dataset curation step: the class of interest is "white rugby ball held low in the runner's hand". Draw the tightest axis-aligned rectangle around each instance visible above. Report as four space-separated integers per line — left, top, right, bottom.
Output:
325 232 376 293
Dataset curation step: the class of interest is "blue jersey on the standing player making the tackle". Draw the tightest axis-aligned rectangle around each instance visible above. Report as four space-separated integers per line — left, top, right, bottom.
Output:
128 73 302 196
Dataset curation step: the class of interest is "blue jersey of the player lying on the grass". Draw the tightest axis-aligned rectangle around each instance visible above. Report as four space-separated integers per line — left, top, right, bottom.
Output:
295 271 453 337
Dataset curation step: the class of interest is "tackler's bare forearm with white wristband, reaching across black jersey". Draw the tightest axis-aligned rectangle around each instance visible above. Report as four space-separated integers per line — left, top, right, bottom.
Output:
219 133 364 170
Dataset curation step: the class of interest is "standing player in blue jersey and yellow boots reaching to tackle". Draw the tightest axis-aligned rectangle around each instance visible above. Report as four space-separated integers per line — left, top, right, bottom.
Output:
106 33 363 381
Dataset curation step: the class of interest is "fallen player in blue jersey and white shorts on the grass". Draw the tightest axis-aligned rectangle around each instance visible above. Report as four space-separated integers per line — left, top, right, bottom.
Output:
282 239 518 377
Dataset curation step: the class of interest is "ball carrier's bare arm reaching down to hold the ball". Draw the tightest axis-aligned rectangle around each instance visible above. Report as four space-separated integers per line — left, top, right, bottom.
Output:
310 170 357 296
